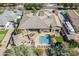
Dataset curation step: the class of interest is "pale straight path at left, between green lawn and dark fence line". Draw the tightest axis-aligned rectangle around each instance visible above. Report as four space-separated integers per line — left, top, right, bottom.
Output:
0 29 14 56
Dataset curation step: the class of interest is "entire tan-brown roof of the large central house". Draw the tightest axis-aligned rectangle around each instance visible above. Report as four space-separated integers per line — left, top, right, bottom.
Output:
19 14 60 29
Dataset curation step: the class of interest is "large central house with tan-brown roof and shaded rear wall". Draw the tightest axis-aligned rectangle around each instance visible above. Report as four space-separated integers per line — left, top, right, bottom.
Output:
19 14 62 31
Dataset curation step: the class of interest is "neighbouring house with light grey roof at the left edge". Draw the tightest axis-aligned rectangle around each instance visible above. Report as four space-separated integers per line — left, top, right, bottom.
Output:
0 10 21 29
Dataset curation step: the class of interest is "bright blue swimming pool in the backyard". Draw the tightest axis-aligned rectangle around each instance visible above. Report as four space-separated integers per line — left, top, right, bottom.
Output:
39 34 51 44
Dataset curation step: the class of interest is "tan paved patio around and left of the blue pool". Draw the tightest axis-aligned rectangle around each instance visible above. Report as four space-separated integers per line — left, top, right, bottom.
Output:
13 30 59 48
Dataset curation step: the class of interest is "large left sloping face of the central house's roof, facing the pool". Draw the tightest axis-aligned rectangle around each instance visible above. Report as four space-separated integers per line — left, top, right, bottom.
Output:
19 16 48 29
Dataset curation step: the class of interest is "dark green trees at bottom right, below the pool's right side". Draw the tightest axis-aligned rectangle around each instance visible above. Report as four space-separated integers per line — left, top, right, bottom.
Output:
47 42 79 56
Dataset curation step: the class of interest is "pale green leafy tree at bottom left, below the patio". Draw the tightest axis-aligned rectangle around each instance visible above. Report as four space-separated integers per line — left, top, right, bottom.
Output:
4 45 36 56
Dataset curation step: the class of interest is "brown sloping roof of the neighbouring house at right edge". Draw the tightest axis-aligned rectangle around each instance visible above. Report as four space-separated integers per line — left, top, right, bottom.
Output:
68 10 79 33
